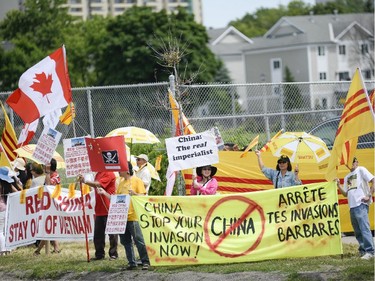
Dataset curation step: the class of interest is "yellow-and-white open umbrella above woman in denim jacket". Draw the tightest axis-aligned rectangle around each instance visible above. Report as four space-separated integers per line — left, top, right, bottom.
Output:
270 132 330 164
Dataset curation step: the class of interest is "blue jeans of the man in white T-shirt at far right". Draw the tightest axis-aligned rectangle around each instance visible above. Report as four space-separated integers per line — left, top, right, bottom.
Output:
350 204 374 255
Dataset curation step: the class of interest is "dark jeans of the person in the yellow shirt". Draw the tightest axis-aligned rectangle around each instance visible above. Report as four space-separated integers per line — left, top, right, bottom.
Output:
120 221 150 266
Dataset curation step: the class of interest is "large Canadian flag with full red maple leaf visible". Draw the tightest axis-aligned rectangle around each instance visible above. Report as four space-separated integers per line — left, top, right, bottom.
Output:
6 46 72 123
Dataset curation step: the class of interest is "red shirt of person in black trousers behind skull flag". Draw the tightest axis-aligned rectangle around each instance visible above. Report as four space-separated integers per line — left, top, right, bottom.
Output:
95 172 116 216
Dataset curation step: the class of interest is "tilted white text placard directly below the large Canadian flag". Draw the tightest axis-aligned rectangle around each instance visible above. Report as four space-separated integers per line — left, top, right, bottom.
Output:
33 127 61 164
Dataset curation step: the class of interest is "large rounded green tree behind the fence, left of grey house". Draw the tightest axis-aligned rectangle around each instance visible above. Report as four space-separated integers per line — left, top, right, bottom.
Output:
96 7 219 85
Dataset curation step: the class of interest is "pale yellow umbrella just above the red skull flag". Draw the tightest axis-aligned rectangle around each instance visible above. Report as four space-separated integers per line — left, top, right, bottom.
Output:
106 127 160 144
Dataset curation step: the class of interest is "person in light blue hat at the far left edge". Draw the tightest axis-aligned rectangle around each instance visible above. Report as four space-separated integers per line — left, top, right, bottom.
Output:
0 167 17 256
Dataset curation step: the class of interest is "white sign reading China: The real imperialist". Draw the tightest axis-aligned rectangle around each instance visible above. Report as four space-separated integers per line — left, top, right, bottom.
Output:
165 131 219 171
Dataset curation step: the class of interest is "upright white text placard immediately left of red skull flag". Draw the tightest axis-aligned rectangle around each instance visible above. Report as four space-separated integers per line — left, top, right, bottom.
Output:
63 137 91 178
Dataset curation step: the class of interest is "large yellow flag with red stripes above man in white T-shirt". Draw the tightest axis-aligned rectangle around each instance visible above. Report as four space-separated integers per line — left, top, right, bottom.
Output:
325 68 375 181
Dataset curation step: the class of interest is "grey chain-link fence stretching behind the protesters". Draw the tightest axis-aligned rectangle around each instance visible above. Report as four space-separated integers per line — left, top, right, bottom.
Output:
0 81 374 147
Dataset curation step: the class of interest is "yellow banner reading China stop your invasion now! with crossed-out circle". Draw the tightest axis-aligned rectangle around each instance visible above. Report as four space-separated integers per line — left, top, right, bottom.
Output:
131 182 342 266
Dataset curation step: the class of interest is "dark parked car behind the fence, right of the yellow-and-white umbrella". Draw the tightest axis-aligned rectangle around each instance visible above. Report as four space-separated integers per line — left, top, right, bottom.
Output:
309 117 375 149
